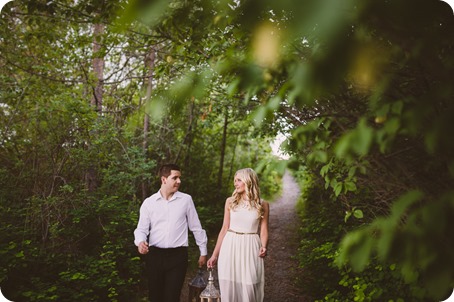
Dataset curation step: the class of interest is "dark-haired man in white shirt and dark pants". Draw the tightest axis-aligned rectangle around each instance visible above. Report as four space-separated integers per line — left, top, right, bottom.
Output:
134 164 208 302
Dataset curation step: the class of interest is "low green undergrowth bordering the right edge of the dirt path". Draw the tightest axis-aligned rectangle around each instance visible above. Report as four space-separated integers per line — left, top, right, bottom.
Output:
295 169 435 301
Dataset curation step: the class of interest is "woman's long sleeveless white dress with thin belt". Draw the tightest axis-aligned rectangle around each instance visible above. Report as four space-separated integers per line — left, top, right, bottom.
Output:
218 206 265 302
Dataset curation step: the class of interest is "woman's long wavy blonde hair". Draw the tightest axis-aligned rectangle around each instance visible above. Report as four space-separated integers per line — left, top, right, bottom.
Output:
230 168 264 217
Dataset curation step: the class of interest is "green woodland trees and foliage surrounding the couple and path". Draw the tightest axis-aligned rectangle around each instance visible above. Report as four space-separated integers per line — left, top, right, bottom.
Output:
0 0 454 301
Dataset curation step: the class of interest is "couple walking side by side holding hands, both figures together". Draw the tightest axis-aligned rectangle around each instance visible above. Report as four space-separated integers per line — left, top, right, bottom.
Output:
134 164 269 302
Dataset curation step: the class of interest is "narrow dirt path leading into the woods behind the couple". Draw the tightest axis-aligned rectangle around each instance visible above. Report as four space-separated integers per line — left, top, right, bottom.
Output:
181 173 311 302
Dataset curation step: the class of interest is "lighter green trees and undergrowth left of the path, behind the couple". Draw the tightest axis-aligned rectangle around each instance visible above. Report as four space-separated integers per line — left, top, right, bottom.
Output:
0 1 279 301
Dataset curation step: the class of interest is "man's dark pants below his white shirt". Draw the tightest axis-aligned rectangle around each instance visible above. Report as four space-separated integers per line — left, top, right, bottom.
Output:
146 246 188 302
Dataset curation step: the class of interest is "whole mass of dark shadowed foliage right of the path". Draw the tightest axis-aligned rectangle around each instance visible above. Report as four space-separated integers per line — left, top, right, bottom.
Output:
289 1 454 301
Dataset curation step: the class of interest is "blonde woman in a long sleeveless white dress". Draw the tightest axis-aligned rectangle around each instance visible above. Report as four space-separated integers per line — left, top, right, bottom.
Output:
207 168 269 302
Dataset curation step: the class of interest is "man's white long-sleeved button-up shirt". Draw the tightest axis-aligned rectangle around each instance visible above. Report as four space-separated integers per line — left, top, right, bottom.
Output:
134 191 208 256
